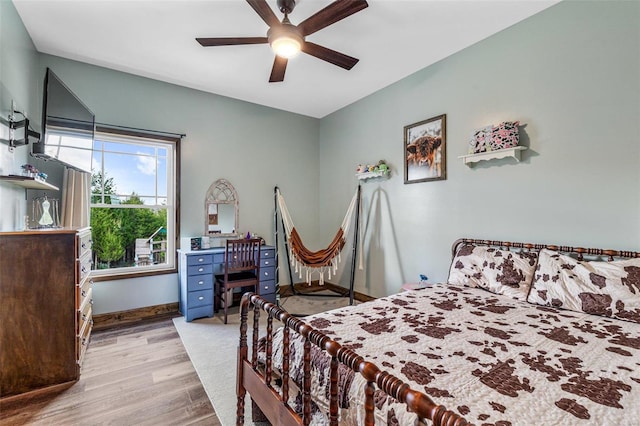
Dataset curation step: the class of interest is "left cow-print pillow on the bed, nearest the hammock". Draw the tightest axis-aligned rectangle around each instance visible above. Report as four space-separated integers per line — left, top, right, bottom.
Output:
448 244 537 300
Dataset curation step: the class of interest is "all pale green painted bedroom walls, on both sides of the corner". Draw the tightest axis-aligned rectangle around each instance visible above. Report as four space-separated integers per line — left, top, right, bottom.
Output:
0 0 640 313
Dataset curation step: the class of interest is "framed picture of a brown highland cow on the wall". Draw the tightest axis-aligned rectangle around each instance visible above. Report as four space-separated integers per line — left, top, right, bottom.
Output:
404 114 447 183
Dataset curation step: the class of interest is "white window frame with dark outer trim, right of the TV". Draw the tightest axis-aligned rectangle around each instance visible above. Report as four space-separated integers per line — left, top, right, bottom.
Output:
90 127 180 281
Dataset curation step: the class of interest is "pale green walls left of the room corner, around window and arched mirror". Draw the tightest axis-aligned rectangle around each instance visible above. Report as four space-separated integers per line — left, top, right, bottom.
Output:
0 0 319 314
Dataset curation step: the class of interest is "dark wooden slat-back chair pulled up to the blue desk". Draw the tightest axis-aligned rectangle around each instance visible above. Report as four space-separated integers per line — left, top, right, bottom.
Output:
216 239 260 324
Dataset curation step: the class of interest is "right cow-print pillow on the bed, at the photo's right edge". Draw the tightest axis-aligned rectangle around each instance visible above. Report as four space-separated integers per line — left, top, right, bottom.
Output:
527 249 640 323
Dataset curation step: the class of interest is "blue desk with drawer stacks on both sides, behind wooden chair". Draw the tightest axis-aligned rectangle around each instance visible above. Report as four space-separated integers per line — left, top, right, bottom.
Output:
178 246 276 322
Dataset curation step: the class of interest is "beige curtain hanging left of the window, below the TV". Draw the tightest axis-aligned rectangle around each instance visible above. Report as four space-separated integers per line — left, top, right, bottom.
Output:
62 168 91 228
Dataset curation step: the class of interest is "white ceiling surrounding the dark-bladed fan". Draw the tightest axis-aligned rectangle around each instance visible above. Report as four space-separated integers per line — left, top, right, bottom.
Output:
13 0 558 118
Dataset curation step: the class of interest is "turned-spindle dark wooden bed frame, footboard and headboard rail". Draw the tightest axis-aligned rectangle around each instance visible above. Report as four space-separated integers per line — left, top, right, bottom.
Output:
236 238 640 426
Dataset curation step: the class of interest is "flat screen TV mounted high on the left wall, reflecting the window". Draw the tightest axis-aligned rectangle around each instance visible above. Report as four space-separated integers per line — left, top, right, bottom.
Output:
33 68 95 172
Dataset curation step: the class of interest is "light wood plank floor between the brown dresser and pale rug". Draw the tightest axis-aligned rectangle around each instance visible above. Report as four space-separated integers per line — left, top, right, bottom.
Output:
0 319 221 426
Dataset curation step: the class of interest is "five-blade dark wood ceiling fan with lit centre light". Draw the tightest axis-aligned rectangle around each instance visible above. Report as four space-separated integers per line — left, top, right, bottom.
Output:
196 0 369 83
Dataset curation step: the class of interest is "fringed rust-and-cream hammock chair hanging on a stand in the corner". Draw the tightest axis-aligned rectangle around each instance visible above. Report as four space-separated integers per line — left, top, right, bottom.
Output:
276 189 358 285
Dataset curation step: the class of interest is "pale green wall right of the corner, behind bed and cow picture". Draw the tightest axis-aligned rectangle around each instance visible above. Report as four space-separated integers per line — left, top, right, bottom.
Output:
320 1 640 296
